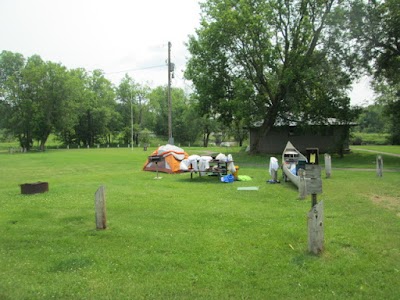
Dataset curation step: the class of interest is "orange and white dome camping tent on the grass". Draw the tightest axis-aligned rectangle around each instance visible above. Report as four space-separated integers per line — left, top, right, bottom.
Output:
143 144 188 173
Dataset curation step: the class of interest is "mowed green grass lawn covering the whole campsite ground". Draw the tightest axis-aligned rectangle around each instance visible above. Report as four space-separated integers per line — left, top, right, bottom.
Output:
0 148 400 299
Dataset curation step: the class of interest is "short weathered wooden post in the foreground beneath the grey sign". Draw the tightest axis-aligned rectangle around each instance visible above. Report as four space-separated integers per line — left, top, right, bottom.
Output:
308 201 324 254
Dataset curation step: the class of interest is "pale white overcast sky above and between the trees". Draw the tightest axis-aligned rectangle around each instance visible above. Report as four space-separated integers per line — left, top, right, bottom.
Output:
0 0 372 104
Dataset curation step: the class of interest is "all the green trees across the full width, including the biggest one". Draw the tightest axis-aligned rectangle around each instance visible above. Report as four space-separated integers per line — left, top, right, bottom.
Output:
0 0 400 152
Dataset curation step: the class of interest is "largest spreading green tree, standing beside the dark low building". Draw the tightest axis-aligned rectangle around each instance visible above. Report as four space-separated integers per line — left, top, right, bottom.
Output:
186 0 355 152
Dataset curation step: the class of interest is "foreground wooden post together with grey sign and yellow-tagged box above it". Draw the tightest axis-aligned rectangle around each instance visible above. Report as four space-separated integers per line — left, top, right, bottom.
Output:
306 148 324 254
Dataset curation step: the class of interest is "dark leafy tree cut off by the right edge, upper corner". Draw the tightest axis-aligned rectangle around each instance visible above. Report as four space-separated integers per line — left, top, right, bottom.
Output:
348 0 400 144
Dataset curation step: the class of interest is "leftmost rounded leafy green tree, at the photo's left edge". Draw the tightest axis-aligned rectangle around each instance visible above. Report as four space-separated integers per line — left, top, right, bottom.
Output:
0 51 77 150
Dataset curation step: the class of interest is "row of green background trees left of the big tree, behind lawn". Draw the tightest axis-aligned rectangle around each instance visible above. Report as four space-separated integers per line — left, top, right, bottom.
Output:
0 51 233 150
